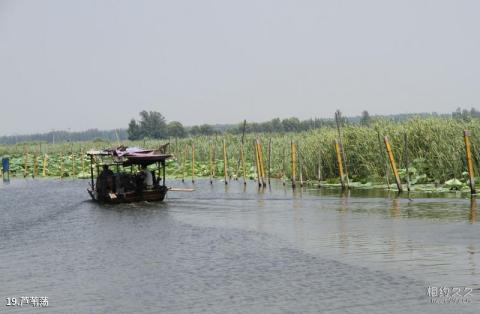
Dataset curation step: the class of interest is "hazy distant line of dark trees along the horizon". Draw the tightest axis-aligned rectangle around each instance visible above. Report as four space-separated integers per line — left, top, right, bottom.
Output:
0 107 480 144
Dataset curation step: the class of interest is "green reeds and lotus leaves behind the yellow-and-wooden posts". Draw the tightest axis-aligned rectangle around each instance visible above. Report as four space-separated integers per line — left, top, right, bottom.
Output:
0 117 480 184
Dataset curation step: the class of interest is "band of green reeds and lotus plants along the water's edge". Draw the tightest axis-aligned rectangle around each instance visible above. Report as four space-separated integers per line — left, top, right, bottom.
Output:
0 116 480 192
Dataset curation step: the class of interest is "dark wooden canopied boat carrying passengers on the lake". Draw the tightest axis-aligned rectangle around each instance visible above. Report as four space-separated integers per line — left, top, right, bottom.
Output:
87 147 172 204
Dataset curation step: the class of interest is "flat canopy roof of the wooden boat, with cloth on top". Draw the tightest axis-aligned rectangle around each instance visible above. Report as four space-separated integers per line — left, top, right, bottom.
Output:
87 146 172 166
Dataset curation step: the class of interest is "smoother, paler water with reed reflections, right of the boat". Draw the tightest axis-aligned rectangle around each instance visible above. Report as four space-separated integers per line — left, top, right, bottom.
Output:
172 179 480 296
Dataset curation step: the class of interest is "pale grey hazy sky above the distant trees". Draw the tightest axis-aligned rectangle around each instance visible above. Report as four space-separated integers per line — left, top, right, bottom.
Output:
0 0 480 135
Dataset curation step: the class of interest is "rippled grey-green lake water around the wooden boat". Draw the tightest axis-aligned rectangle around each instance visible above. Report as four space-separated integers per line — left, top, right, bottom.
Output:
0 179 480 313
